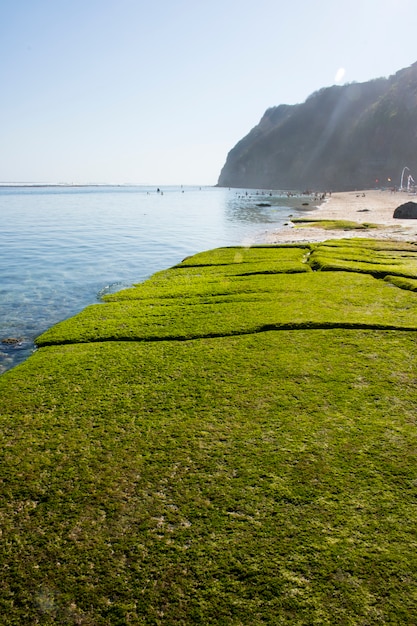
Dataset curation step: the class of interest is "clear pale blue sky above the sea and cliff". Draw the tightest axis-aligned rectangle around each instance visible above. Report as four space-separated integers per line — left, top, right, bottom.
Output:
0 0 417 185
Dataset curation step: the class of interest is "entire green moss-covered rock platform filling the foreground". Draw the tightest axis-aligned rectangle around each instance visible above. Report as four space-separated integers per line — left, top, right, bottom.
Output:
0 239 417 626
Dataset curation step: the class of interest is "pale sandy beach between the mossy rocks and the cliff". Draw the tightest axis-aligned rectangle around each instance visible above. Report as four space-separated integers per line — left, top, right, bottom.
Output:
264 190 417 243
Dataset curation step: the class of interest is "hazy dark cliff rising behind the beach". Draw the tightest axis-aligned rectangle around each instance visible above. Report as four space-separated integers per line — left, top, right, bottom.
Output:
218 63 417 191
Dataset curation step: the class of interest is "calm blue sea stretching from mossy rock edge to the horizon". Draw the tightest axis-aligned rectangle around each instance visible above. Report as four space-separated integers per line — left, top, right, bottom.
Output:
0 186 301 373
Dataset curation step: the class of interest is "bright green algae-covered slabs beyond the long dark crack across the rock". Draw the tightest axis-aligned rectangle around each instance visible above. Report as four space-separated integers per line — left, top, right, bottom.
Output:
37 242 417 346
